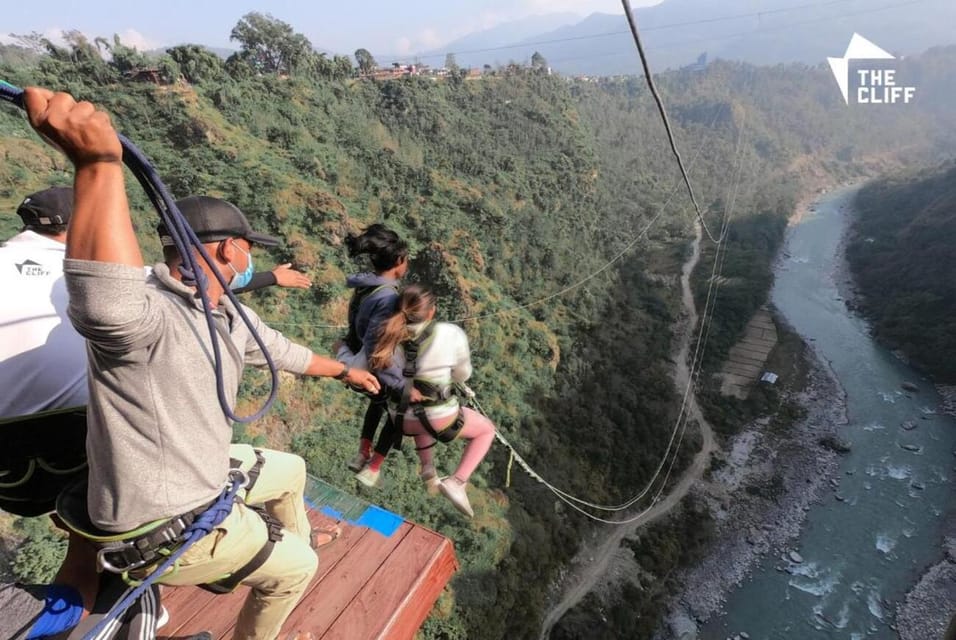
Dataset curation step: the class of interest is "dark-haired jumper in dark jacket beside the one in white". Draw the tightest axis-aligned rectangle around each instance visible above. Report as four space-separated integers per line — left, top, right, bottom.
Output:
336 224 408 487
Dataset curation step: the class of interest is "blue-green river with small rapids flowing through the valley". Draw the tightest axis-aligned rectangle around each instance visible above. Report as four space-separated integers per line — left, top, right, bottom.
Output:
700 182 956 640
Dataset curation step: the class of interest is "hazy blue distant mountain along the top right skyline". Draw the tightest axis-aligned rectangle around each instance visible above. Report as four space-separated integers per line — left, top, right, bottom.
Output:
429 0 956 75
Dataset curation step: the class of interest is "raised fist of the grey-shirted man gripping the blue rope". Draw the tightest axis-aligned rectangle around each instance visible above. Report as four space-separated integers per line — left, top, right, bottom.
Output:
24 87 123 167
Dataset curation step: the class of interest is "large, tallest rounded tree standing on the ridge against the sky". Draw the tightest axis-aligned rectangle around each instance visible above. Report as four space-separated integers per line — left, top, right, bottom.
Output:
229 11 314 74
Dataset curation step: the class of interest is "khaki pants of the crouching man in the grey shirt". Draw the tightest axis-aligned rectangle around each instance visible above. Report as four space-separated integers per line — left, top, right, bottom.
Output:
160 445 319 640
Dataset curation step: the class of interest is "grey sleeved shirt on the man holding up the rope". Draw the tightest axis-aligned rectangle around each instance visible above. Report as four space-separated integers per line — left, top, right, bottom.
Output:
64 259 312 532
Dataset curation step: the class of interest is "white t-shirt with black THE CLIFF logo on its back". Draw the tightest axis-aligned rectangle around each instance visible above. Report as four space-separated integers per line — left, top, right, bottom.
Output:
0 231 89 418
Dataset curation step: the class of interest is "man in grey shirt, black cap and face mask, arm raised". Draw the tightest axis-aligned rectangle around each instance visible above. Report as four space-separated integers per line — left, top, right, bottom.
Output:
24 88 379 640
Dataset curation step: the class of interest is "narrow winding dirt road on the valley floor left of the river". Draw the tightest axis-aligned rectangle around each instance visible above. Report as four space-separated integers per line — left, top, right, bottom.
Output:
541 225 716 640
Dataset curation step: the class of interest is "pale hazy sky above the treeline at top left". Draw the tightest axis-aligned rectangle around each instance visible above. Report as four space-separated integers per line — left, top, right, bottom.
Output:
0 0 661 54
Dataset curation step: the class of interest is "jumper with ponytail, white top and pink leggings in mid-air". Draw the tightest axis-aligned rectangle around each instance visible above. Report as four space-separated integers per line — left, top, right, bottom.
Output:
369 285 495 517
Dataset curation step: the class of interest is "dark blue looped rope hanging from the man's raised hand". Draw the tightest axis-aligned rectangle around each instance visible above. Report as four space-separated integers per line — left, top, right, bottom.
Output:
0 80 279 422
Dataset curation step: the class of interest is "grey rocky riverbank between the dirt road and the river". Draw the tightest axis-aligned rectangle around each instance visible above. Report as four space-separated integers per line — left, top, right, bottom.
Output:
661 349 846 640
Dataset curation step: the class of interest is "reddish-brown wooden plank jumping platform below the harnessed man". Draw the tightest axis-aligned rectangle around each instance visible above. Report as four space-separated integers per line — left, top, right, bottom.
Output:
159 511 458 640
